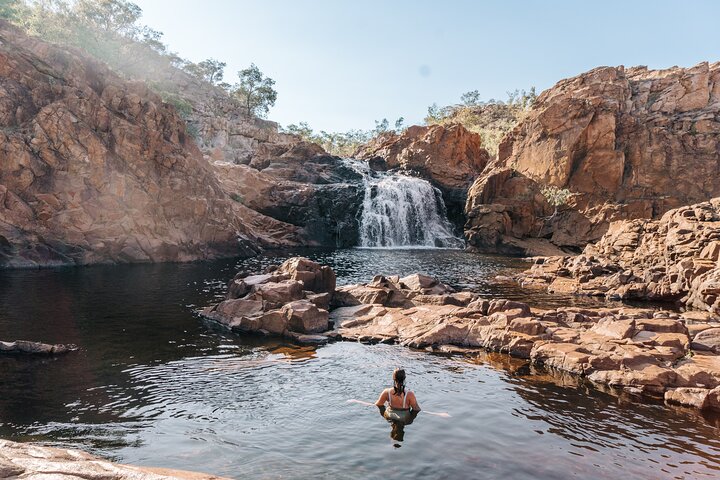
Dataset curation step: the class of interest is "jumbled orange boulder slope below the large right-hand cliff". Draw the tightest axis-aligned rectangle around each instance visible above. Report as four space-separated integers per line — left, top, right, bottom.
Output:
518 198 720 316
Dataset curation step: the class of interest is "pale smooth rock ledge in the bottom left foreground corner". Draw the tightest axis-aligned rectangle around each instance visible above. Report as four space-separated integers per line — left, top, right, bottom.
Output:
0 440 228 480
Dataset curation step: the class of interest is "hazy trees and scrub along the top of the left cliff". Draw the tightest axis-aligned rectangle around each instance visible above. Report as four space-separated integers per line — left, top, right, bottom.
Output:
0 0 277 122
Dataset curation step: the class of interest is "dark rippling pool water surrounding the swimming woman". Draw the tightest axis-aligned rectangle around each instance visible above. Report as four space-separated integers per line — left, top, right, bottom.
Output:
0 250 720 479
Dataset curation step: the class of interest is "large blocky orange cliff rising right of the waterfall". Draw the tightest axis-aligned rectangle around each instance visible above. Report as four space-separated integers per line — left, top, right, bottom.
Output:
466 63 720 253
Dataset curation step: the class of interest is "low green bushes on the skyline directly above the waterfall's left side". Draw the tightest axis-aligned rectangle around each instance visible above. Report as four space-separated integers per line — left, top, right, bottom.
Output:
282 117 405 157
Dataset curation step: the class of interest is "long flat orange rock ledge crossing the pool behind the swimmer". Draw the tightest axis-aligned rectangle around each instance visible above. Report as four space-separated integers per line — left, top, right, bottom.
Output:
203 258 720 410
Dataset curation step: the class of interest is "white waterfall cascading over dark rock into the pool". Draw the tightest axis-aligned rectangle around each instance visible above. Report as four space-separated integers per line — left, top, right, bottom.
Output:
347 160 464 248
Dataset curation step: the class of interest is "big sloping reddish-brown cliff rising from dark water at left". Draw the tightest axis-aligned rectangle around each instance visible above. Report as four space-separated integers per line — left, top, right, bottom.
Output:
0 22 300 266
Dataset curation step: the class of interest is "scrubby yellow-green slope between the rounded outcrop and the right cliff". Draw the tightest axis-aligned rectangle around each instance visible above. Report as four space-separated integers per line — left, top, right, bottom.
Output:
425 87 537 155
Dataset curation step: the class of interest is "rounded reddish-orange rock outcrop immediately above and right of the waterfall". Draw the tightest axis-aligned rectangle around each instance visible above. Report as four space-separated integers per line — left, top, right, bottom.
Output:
356 125 490 229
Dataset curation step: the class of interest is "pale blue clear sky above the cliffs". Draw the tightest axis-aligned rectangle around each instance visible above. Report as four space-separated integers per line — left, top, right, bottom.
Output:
134 0 720 131
